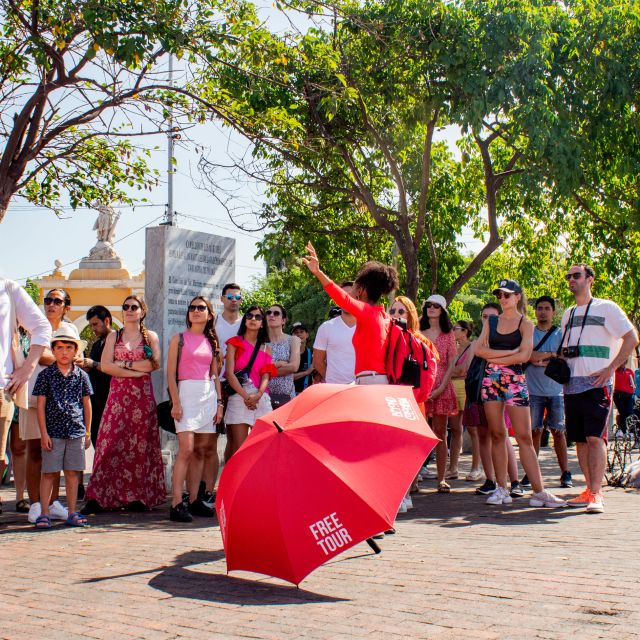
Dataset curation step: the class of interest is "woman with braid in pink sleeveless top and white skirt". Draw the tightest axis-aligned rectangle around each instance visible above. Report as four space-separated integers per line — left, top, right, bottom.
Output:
167 296 222 522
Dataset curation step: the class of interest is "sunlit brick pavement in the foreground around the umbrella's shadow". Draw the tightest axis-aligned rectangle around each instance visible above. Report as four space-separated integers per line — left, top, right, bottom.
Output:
0 444 640 640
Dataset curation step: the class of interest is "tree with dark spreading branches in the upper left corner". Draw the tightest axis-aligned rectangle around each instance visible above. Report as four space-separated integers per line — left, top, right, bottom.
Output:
0 0 251 222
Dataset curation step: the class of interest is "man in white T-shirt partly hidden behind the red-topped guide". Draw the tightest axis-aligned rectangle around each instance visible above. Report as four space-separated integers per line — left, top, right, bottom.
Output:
313 282 356 384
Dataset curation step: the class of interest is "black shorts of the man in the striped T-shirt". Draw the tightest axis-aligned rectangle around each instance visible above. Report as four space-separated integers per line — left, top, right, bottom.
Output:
564 387 611 442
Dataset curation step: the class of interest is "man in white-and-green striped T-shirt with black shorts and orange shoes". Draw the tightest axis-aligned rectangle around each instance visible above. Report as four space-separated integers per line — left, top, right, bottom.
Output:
562 263 638 513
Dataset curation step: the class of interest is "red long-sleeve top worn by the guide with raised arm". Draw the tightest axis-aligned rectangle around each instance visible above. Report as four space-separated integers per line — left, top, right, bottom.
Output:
324 282 391 375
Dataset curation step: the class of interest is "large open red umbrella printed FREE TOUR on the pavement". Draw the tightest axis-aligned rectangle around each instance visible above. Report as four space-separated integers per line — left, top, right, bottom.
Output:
216 384 438 584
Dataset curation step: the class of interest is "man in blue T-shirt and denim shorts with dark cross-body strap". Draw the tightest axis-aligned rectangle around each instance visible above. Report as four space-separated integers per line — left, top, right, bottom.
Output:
521 296 573 489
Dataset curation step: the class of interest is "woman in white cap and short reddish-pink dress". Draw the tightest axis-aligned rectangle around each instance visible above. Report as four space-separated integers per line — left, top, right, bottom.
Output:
420 294 459 493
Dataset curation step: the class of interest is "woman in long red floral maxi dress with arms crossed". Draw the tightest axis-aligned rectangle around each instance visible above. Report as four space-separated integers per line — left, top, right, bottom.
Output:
82 296 166 514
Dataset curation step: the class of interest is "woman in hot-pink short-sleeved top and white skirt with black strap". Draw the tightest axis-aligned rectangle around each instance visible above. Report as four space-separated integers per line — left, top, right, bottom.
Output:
224 305 278 455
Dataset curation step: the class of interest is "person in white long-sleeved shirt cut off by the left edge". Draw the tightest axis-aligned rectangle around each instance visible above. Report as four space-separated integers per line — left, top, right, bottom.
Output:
0 278 51 477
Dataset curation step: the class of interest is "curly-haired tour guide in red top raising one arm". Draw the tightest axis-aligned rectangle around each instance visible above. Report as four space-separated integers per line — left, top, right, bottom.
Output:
302 242 399 384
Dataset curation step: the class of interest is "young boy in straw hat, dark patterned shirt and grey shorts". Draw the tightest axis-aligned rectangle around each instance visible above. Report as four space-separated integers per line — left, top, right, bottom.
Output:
33 324 93 529
